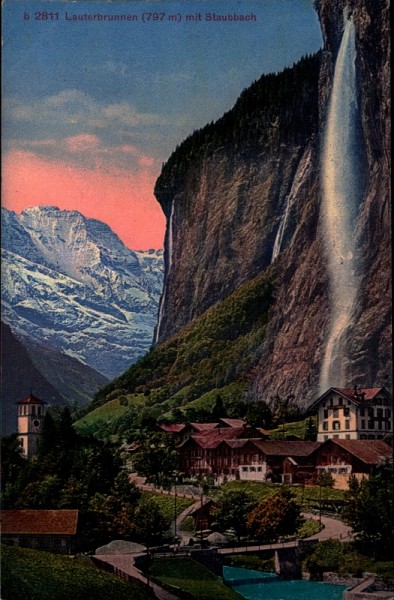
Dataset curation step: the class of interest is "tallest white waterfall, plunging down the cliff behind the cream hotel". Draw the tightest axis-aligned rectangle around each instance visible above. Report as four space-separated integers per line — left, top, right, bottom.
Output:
320 17 362 393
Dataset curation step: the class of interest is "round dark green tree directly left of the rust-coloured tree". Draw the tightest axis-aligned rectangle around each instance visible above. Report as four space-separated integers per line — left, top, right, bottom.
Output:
213 490 254 541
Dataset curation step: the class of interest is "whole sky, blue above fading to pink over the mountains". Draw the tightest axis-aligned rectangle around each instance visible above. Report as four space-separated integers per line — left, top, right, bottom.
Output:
2 0 322 250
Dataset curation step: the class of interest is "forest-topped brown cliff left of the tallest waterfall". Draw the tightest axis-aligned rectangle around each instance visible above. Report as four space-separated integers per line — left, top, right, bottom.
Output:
155 57 320 341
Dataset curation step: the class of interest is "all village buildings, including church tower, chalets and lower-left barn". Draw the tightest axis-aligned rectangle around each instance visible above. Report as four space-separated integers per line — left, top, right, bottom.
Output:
2 387 393 553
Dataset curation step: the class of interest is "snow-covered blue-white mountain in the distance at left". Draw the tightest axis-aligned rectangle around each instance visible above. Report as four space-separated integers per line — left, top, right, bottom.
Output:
2 206 163 378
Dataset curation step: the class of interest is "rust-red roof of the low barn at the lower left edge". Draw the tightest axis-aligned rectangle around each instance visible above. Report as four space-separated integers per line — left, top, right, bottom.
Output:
1 510 78 535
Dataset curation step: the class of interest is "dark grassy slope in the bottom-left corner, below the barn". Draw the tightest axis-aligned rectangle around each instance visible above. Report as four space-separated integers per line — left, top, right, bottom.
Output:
1 545 152 600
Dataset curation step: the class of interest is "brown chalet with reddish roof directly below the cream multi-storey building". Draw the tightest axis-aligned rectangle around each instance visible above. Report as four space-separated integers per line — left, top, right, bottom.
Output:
311 439 393 489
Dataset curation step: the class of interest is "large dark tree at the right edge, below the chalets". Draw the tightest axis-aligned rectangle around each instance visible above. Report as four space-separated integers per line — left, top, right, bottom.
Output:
342 461 394 558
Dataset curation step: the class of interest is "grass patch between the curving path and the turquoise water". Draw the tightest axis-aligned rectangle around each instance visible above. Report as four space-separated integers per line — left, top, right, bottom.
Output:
150 558 240 600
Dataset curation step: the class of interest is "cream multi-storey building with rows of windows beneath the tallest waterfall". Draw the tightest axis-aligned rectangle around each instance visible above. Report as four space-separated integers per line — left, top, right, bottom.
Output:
311 387 393 442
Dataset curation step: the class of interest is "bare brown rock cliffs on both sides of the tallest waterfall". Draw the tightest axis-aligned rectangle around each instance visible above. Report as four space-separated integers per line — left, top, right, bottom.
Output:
156 0 391 405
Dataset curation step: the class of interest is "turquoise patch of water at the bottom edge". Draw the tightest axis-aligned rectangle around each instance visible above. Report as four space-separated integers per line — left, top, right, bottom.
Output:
223 567 346 600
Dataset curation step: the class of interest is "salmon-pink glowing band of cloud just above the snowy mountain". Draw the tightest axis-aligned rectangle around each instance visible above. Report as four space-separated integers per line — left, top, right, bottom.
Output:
2 154 165 250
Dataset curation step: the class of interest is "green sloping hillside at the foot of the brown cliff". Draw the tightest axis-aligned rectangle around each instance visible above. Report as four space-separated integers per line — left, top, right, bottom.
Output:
83 272 274 429
